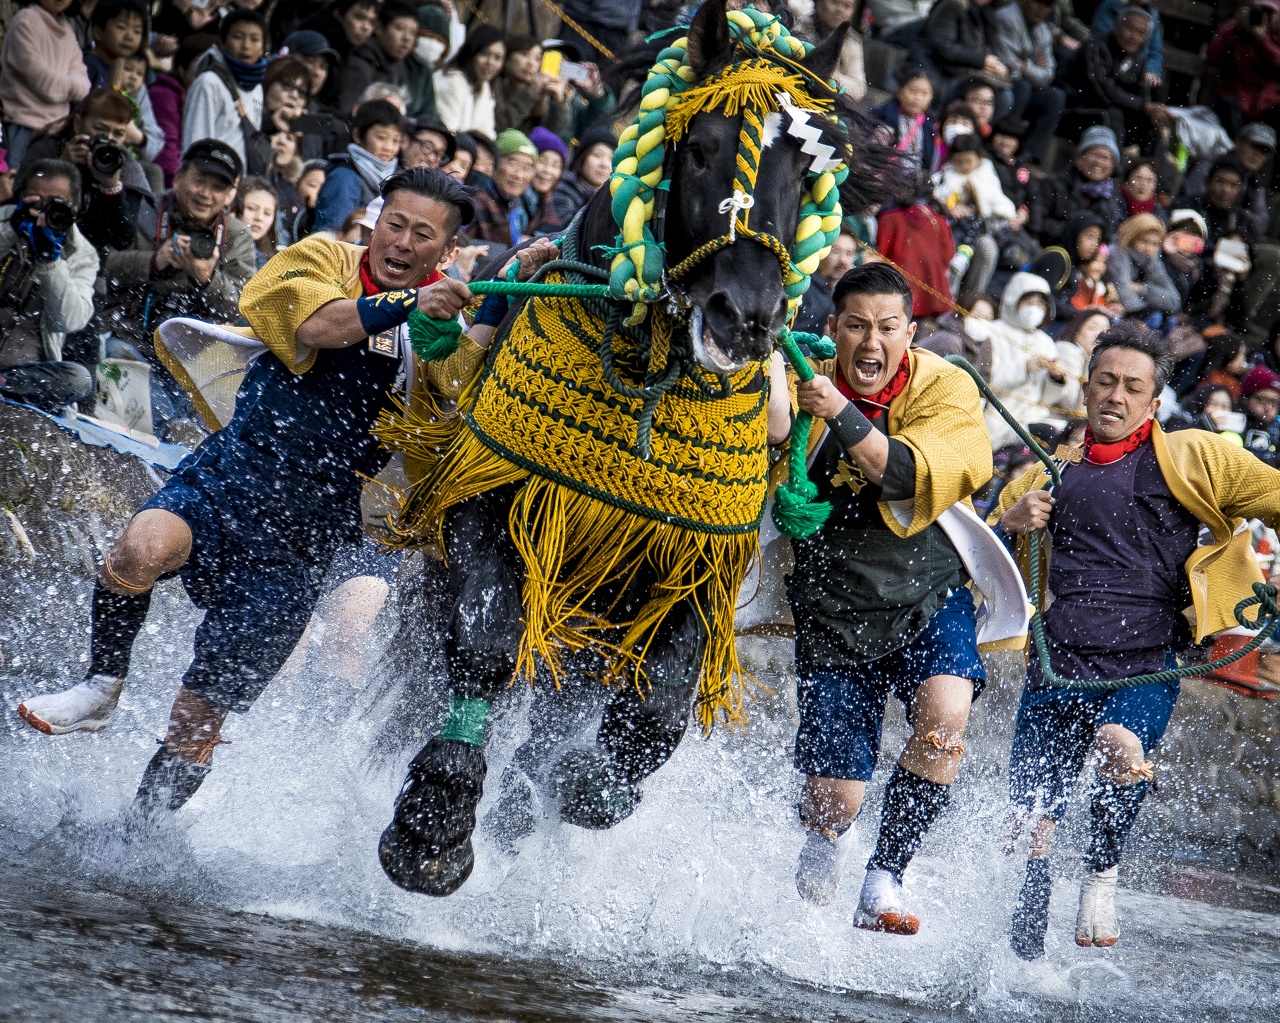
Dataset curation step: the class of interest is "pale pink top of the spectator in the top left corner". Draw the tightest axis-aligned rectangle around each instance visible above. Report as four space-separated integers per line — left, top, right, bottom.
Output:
0 4 90 129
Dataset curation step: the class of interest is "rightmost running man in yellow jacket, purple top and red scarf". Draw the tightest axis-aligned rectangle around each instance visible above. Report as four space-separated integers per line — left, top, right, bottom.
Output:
992 323 1280 959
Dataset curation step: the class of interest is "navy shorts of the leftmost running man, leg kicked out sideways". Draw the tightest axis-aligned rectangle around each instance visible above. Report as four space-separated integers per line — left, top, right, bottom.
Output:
140 476 328 712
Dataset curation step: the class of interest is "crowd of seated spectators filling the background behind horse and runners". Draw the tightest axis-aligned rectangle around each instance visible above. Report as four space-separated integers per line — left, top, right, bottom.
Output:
0 0 1280 489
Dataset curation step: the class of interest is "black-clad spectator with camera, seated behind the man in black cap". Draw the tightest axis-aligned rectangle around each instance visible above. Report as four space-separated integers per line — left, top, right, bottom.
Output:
24 88 155 260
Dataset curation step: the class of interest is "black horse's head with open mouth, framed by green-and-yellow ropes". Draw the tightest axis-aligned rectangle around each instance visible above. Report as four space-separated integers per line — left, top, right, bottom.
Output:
666 0 849 373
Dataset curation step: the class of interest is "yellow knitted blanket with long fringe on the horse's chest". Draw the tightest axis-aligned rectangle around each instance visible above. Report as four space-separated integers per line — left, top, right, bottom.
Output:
378 275 768 729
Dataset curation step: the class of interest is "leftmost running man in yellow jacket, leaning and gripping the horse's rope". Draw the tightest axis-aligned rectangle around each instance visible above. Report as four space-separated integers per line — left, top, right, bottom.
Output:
18 169 552 812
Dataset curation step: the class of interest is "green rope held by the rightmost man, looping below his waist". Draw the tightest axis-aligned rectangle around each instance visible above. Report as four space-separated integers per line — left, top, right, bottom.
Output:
947 355 1280 691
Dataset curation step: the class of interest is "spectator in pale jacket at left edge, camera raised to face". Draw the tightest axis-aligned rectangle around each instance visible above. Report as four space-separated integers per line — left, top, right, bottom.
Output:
0 160 99 414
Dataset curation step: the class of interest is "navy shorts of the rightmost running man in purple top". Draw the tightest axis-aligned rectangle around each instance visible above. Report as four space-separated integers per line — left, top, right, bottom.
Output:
1009 657 1179 821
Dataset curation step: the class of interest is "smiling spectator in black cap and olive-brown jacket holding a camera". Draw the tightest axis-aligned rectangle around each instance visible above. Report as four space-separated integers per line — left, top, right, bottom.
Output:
105 138 256 360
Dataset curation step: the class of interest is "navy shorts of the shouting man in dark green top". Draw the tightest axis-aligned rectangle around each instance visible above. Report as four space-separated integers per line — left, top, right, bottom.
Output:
795 589 987 781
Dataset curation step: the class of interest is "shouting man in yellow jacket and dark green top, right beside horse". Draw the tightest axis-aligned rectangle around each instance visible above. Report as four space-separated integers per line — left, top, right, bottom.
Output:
769 262 991 935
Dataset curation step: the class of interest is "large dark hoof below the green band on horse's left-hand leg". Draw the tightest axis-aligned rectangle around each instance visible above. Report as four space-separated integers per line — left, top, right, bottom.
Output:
378 737 486 895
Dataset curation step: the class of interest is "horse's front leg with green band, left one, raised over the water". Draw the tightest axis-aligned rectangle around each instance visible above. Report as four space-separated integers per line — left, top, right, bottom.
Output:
378 492 524 895
